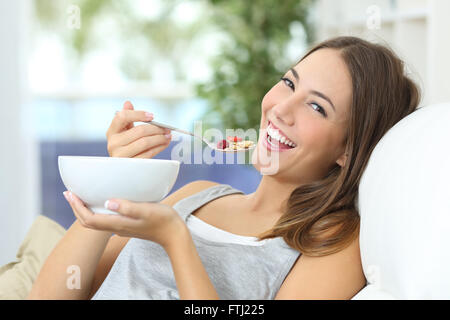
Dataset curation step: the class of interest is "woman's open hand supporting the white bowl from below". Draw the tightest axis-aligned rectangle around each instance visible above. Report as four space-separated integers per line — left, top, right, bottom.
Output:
65 191 187 248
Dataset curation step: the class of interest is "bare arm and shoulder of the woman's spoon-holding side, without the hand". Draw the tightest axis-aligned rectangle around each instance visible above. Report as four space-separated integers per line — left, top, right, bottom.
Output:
28 181 217 299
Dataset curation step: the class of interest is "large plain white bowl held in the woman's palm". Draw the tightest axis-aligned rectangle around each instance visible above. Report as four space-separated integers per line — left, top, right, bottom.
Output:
58 156 180 214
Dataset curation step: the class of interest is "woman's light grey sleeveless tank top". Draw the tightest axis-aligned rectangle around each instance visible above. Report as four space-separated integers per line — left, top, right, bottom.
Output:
92 184 300 300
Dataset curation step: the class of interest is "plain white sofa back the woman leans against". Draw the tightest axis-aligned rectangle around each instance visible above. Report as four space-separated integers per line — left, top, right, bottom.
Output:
353 103 450 300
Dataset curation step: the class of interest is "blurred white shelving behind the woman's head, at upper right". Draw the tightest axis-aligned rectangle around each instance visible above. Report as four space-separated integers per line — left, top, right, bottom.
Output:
315 0 450 105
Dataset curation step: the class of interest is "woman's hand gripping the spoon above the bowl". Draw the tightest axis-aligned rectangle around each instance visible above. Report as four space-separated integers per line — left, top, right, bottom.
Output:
106 101 172 159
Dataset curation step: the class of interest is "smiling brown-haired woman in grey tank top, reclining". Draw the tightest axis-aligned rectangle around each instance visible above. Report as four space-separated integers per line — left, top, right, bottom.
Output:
29 37 419 299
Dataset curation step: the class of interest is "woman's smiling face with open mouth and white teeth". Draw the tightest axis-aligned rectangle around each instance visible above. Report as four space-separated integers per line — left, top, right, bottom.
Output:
253 49 352 183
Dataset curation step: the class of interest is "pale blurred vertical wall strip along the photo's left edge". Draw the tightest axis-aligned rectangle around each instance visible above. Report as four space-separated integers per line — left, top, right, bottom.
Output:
0 0 40 263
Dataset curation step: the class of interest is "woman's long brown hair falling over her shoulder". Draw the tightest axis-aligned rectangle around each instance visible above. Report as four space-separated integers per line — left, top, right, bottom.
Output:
260 37 420 256
